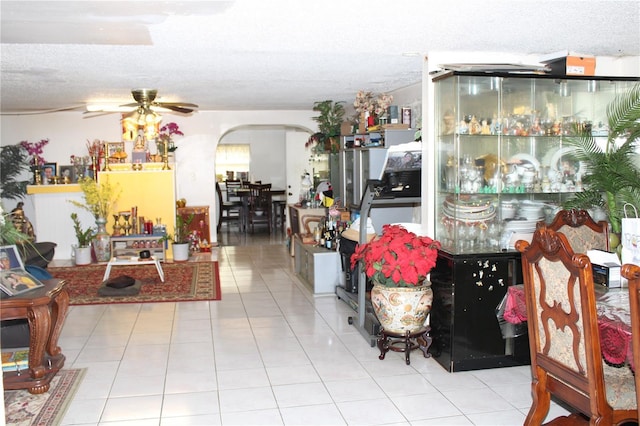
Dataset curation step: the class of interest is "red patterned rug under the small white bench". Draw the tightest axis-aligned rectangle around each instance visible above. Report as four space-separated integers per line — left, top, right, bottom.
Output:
47 262 221 305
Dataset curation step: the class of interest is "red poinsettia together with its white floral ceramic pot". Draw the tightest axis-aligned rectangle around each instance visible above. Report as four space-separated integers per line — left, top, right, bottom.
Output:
351 225 440 334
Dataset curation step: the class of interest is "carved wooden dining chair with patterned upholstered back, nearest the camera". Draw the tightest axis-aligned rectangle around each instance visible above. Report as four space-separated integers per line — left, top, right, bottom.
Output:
516 226 638 425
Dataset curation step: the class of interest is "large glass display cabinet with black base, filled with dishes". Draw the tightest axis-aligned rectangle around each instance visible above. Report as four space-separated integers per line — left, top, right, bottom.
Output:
430 72 637 372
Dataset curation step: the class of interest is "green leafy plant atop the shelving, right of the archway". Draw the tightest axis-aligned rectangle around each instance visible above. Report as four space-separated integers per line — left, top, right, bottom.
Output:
305 100 345 153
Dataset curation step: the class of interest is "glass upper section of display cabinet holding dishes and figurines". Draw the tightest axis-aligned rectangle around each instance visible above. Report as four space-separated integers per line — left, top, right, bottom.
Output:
434 72 638 254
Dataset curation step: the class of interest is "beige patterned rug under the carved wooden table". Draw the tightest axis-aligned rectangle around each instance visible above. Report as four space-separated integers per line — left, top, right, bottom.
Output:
4 368 86 426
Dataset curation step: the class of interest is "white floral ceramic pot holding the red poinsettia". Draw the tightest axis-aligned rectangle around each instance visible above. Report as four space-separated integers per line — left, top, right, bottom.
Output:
371 280 433 334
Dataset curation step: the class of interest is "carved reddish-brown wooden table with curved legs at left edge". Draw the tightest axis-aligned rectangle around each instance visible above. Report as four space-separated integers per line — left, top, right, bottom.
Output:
0 279 69 394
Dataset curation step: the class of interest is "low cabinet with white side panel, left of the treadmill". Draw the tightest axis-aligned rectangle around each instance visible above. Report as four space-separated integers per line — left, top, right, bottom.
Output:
293 236 343 294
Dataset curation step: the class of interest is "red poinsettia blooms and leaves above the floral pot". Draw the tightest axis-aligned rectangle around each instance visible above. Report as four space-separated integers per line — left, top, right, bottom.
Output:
351 225 440 287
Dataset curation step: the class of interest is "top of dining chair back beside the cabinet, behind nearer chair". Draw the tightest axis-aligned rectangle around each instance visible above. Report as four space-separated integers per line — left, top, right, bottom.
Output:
547 209 609 253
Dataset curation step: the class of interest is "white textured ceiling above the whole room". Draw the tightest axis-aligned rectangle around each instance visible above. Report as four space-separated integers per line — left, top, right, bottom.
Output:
0 0 640 113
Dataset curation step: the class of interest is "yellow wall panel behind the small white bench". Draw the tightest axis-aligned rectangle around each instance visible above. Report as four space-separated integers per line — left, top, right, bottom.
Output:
98 170 176 259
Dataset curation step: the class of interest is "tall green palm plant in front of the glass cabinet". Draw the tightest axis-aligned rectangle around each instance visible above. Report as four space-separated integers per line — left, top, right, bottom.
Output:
564 84 640 233
